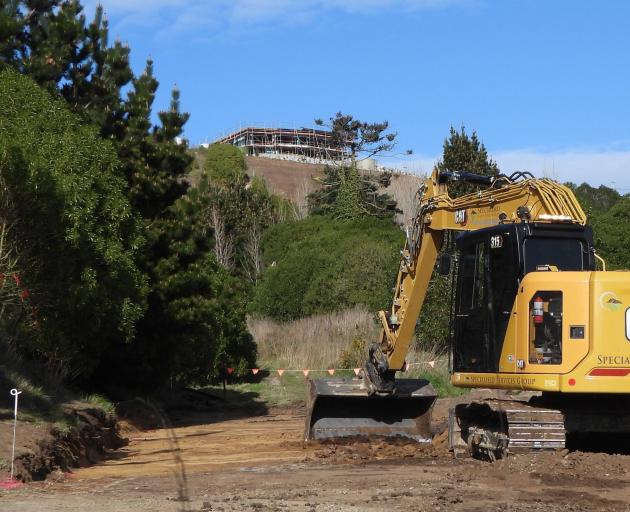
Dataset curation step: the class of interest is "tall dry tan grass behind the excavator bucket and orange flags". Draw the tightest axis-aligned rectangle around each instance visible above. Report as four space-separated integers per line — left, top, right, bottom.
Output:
212 308 467 406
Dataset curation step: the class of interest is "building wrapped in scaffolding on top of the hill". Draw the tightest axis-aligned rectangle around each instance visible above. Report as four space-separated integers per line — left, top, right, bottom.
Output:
215 127 347 163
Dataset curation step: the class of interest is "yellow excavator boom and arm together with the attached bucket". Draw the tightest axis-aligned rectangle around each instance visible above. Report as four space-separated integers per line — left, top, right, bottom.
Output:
305 170 586 441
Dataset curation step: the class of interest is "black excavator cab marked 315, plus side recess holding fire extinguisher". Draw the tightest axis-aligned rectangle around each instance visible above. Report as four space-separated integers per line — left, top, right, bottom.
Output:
452 222 594 373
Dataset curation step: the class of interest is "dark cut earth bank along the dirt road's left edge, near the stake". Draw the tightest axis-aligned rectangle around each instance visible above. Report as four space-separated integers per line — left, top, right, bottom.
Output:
10 402 126 482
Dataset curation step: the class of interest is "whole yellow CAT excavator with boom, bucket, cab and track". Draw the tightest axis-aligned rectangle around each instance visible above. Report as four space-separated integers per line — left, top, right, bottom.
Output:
305 170 630 459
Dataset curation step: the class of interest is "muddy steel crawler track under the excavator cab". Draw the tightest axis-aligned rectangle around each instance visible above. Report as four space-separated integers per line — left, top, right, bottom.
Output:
449 399 566 460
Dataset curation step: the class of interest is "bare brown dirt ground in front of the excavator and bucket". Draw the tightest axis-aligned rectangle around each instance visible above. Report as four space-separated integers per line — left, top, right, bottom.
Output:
0 407 630 512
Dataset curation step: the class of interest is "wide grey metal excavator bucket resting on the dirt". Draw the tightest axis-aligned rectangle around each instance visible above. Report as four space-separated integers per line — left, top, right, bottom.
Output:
304 378 437 442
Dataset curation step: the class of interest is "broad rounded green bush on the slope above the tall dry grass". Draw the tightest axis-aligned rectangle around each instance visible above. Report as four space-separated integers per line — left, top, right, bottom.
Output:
251 216 404 320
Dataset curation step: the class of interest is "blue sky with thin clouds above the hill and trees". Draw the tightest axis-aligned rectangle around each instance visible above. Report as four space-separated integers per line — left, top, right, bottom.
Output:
83 0 630 189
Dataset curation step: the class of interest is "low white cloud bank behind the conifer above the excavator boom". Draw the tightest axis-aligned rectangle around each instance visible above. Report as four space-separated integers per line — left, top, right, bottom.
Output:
396 148 630 194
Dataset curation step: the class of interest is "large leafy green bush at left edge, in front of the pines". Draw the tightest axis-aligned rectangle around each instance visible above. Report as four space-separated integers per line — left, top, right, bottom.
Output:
0 71 146 374
